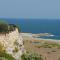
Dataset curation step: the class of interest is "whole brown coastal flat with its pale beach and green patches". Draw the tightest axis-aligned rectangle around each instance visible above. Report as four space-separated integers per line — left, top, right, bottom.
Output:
21 33 60 60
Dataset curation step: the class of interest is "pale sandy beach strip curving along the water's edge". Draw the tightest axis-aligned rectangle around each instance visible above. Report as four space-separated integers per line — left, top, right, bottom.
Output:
21 33 60 43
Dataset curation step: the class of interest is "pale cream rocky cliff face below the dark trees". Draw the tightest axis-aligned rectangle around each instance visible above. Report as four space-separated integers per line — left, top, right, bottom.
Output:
0 24 25 60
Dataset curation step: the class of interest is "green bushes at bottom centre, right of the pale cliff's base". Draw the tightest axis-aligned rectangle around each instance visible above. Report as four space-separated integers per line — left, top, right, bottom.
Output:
21 53 43 60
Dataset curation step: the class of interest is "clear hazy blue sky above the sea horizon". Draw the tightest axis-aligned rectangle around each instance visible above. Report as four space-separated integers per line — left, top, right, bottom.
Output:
0 0 60 19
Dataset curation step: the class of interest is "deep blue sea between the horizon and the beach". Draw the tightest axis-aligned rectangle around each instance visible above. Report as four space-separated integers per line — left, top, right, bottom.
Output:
0 19 60 40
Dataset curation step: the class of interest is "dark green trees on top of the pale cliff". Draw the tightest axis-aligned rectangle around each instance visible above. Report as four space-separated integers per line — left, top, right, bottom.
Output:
0 21 20 33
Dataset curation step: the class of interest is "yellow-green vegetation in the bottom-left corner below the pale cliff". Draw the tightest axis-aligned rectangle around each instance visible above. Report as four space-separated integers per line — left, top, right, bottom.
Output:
0 43 15 60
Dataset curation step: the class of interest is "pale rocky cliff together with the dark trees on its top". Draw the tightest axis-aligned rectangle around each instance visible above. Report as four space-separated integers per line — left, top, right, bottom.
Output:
0 24 25 60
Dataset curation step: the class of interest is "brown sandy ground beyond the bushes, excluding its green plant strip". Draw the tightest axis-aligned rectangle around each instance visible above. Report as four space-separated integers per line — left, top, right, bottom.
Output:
23 37 60 60
